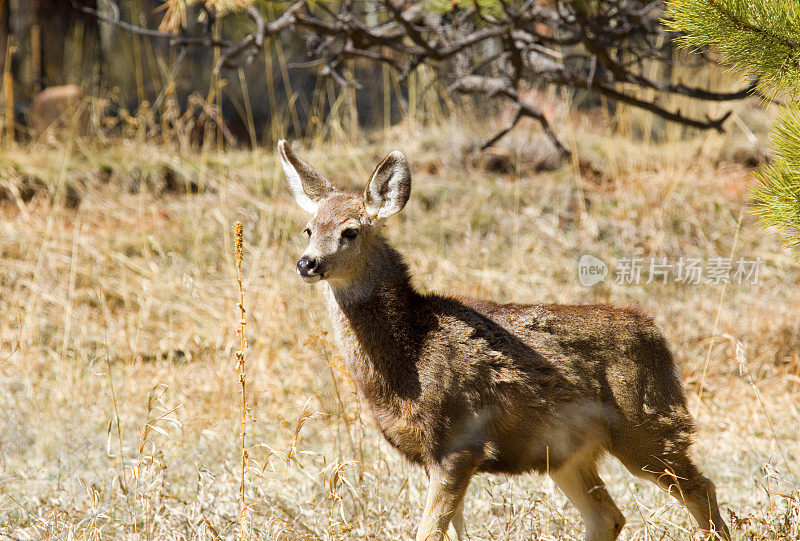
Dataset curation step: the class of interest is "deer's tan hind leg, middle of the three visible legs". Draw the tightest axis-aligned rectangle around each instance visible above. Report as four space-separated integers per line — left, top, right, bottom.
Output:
550 458 625 541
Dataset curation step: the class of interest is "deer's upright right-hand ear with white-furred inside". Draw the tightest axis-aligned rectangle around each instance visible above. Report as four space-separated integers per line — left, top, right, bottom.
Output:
364 150 411 218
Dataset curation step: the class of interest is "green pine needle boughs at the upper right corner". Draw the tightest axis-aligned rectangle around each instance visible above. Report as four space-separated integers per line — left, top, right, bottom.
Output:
664 0 800 260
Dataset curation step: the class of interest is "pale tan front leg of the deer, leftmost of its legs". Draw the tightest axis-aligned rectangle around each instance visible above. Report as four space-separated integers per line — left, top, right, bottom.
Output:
417 452 477 541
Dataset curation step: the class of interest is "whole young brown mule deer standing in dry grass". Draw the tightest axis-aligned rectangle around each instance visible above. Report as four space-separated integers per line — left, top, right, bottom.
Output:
278 141 730 541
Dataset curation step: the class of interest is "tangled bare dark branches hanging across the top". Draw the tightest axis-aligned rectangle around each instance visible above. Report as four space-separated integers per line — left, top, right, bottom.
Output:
73 0 757 148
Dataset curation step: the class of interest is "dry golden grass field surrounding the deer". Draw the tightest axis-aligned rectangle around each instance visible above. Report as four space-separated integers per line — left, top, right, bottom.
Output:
0 110 800 540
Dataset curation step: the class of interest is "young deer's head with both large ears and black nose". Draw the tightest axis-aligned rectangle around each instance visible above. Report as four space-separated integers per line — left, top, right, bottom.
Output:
278 140 411 285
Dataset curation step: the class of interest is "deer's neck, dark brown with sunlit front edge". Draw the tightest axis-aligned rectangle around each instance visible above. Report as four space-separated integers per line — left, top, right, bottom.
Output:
327 239 424 403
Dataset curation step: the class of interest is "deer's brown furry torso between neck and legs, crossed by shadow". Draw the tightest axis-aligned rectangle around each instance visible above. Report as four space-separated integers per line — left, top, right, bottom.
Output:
406 296 691 473
